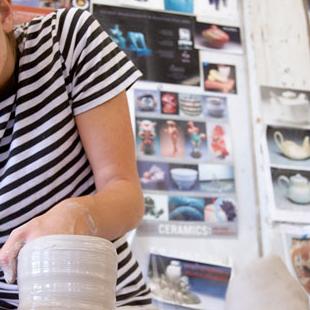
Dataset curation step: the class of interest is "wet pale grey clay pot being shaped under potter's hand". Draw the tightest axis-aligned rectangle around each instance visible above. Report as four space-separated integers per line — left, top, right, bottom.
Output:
17 235 117 310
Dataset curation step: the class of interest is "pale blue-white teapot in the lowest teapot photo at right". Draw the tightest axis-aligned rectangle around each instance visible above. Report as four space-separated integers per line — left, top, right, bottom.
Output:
278 173 310 204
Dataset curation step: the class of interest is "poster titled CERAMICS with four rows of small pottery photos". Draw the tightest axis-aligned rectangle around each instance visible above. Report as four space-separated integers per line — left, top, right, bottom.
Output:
133 83 238 237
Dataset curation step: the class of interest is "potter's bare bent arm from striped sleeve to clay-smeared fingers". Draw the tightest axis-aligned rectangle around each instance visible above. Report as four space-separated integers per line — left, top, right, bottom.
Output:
0 92 144 282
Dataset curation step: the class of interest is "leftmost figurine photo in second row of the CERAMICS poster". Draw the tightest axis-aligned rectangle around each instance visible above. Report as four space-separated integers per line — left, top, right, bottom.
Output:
136 118 160 155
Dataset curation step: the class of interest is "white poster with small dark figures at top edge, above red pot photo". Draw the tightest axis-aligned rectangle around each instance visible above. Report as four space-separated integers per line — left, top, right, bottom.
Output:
194 0 241 25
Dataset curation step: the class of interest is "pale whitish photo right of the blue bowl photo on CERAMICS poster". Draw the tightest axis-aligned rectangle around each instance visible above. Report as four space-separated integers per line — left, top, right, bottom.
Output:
198 164 235 194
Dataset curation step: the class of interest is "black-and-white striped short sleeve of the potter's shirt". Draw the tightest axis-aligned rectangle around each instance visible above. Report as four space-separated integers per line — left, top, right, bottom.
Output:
59 9 142 115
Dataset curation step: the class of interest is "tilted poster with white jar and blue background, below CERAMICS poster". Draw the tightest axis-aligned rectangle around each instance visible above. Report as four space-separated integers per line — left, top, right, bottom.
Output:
148 254 231 310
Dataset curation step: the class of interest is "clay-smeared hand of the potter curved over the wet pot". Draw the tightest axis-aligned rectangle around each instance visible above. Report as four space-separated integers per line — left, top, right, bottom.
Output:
0 202 97 283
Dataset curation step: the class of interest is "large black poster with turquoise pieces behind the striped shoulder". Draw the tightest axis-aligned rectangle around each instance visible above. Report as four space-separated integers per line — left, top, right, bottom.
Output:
93 4 200 86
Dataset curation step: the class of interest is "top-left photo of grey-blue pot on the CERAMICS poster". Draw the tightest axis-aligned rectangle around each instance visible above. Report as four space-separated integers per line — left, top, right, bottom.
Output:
134 89 160 114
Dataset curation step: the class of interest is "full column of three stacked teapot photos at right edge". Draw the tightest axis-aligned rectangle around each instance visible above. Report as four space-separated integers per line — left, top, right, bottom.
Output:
261 86 310 224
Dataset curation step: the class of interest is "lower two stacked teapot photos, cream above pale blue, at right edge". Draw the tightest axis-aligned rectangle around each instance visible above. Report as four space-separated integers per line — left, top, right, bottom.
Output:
266 126 310 224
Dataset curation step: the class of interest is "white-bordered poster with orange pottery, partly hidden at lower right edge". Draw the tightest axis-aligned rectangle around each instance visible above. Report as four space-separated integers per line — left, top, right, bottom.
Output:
282 225 310 297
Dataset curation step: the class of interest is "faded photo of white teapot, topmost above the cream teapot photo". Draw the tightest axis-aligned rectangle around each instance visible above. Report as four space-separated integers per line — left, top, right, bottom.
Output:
261 86 310 125
